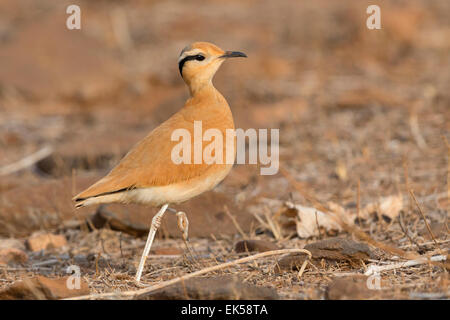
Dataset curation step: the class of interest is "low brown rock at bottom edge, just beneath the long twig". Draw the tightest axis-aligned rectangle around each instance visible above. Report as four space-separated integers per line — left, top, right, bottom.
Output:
140 276 279 300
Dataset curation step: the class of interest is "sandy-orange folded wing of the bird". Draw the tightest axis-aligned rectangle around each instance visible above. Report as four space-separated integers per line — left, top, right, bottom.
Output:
74 101 234 200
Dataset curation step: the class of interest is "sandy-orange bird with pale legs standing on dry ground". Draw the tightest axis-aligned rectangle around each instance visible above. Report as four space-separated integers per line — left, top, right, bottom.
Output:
73 42 247 284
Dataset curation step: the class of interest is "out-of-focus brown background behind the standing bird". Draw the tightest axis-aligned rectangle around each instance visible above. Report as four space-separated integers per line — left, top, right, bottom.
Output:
0 0 450 300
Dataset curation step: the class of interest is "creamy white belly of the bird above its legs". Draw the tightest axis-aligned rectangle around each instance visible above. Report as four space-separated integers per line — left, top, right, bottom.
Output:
121 165 232 206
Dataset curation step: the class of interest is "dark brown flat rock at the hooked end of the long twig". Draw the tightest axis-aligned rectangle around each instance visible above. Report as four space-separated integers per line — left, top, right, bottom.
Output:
275 238 376 273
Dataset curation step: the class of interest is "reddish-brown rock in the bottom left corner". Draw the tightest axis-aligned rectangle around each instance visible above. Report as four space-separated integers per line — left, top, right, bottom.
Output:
0 276 90 300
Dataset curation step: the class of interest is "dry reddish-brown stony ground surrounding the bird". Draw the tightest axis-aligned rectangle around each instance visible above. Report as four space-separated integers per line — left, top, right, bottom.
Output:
0 0 450 299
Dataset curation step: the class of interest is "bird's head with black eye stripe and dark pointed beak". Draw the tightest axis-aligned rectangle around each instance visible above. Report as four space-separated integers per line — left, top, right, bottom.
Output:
178 42 247 93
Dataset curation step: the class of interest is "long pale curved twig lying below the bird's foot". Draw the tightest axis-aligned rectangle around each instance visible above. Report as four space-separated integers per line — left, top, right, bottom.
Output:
68 249 312 300
